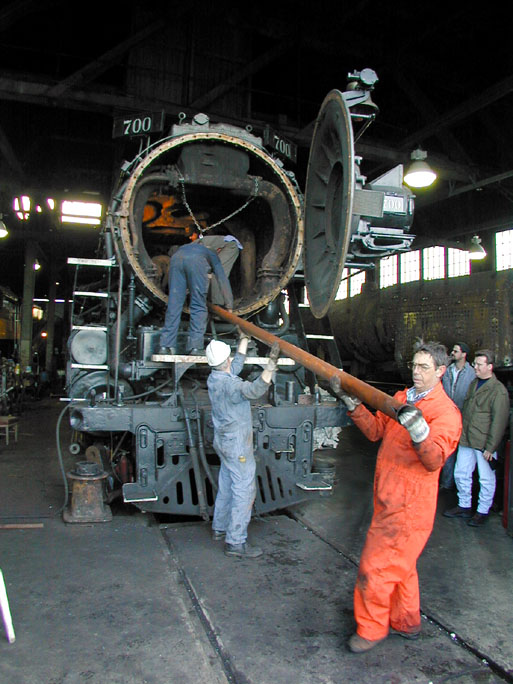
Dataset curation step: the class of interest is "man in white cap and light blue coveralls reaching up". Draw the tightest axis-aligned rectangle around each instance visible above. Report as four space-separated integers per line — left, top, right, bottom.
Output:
206 333 280 558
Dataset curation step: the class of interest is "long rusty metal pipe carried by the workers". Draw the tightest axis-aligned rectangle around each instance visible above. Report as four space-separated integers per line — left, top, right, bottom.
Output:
208 304 404 419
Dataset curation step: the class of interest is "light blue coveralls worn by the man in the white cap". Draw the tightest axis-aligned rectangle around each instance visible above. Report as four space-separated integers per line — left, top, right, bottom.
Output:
207 353 269 544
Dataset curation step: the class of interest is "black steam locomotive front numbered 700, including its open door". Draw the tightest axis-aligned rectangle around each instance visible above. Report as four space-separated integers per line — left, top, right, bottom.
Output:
67 69 413 519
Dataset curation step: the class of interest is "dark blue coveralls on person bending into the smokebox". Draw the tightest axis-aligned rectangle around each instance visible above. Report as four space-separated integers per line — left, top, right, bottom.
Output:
160 240 233 350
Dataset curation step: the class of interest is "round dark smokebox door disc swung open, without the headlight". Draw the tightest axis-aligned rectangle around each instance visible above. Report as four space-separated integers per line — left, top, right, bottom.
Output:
304 90 354 318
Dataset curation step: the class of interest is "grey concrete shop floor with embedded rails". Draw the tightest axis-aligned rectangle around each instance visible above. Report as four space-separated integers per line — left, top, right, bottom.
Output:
0 400 513 684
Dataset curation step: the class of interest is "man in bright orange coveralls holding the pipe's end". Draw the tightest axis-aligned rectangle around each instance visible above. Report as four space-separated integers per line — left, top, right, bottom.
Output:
332 341 461 653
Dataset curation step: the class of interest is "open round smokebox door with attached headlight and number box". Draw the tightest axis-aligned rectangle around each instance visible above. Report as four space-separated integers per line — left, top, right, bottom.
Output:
304 87 415 318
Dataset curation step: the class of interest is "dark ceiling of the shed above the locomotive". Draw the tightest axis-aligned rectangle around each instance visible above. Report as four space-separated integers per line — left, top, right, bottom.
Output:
0 0 513 295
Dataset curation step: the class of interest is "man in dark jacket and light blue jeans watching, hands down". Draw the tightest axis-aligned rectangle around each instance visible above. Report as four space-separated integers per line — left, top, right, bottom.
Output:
444 349 509 527
